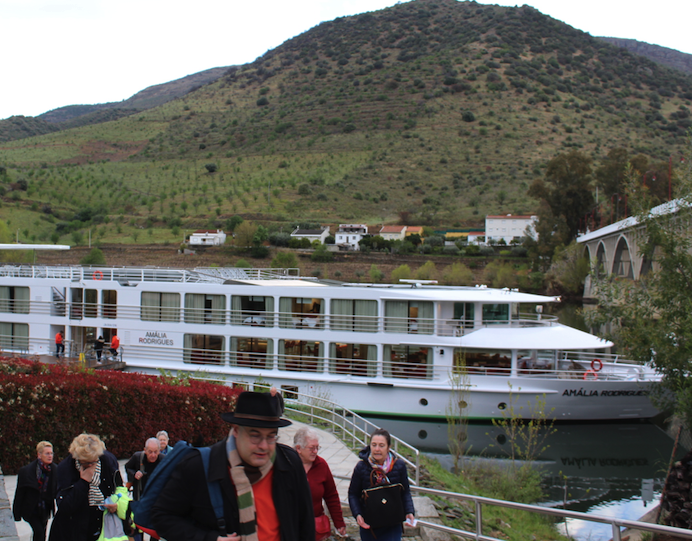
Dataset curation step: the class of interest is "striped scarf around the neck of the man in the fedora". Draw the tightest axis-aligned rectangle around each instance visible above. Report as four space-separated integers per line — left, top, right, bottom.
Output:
226 434 276 541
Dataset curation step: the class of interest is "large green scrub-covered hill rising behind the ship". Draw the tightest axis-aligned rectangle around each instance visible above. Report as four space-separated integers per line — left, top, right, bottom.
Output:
0 0 692 247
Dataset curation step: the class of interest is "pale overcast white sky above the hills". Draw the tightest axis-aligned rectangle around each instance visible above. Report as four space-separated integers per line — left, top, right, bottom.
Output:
0 0 692 119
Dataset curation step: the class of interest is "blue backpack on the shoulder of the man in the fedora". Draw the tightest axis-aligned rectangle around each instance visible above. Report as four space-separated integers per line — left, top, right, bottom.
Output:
130 441 226 539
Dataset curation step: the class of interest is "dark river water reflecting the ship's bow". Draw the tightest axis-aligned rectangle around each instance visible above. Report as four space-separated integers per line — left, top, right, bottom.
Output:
373 419 685 541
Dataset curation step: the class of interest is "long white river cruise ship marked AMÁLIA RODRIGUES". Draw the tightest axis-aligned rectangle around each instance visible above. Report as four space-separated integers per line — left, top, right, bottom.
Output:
0 265 659 421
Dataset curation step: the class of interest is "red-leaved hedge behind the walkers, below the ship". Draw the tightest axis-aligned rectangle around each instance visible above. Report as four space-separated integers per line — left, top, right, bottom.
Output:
0 358 241 474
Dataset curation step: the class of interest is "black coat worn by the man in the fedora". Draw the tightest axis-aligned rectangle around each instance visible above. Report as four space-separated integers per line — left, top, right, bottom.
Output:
151 440 315 541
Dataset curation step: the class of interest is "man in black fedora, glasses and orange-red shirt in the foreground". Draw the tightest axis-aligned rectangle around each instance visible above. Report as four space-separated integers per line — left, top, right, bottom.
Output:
151 391 315 541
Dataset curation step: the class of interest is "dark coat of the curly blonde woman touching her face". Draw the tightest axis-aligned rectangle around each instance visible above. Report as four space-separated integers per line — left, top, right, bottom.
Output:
49 451 123 541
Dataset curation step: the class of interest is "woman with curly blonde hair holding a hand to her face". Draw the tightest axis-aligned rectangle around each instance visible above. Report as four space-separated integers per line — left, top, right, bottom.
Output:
49 434 123 541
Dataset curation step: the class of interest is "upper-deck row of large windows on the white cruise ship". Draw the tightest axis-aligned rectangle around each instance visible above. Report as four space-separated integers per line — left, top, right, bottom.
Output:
0 286 510 326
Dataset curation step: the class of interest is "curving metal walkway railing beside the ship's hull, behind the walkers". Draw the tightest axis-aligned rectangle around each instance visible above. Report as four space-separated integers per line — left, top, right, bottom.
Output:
194 376 420 485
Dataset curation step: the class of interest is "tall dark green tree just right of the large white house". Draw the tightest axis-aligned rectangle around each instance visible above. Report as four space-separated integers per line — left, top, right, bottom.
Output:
529 150 594 239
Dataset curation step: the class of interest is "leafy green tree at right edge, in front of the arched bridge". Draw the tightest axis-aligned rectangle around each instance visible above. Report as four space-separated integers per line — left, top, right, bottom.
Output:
590 148 692 428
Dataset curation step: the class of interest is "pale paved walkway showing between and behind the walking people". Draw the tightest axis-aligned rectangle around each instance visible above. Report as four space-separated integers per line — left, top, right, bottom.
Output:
0 421 358 541
